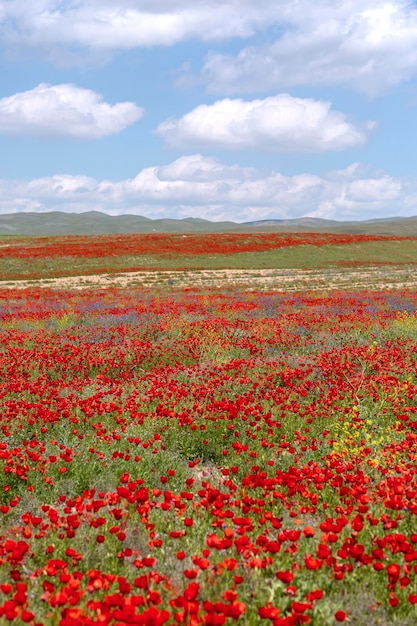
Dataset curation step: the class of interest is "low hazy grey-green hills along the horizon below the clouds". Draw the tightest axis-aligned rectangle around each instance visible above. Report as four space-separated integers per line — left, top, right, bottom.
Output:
0 211 417 237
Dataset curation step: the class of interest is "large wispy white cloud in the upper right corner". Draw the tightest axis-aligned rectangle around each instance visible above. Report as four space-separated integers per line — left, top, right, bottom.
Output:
201 0 417 95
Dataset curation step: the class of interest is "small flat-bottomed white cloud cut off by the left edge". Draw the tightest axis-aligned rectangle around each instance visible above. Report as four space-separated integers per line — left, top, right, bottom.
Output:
0 83 143 139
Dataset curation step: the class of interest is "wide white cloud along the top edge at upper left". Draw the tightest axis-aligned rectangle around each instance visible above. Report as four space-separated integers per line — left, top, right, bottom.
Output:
0 0 300 49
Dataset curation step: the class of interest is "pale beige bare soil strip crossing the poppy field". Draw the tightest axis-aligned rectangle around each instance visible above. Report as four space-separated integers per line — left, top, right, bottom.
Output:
0 265 417 291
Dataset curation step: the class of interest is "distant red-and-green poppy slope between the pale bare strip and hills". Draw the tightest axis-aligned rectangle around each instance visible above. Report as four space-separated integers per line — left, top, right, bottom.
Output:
0 233 417 280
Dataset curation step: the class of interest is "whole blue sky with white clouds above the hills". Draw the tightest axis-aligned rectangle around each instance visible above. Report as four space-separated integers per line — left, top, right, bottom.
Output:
0 0 417 222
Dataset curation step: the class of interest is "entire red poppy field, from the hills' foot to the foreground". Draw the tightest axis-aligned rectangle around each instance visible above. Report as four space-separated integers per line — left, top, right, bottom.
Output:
0 234 417 626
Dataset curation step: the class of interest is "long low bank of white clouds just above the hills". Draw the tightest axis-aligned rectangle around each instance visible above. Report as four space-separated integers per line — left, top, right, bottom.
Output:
0 154 417 221
